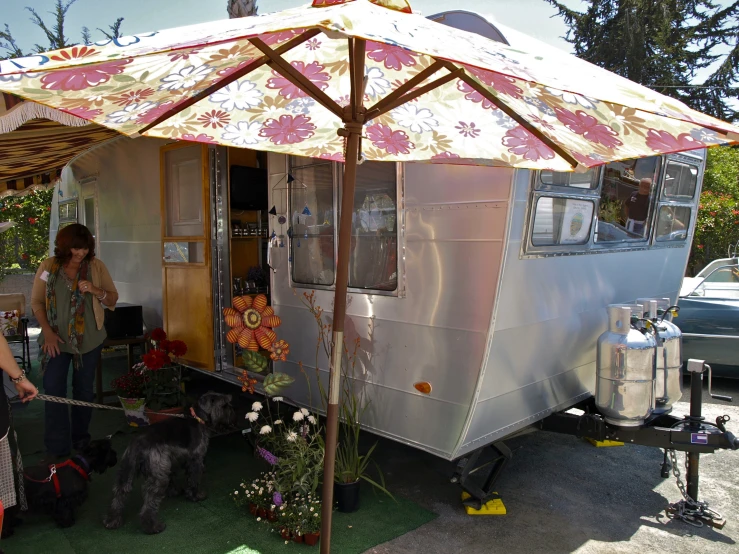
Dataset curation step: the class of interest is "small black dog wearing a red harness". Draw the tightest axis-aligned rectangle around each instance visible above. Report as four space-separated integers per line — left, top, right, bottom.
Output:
10 437 118 535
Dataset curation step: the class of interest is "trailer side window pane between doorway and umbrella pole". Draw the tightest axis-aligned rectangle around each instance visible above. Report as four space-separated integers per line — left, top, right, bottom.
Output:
290 157 336 285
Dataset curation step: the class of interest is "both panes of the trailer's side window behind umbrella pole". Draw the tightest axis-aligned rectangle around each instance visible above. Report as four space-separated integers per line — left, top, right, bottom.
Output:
290 156 398 291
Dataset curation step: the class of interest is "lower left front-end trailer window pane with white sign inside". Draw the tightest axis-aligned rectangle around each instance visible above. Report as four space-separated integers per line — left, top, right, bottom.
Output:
531 196 594 246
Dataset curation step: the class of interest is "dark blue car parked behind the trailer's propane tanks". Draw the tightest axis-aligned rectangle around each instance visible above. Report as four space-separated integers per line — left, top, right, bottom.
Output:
674 251 739 378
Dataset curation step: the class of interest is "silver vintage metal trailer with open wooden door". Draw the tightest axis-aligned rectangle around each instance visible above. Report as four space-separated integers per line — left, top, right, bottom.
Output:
51 12 734 512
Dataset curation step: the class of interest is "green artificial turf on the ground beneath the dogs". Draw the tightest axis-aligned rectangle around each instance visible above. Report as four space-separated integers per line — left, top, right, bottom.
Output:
0 358 436 554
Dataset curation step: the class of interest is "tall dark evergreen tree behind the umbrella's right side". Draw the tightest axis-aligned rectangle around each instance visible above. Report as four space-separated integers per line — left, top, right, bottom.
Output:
546 0 739 120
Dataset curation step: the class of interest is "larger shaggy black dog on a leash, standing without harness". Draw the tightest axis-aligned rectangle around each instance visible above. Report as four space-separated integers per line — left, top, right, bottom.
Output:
103 392 235 535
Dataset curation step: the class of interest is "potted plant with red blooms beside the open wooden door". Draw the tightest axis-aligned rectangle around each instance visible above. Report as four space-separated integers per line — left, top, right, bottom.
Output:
135 329 187 423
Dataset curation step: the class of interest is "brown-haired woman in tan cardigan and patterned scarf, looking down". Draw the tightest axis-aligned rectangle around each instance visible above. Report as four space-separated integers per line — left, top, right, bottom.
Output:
31 223 118 460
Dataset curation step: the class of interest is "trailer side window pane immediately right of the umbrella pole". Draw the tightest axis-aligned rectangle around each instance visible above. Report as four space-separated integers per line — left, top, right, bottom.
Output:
349 162 398 291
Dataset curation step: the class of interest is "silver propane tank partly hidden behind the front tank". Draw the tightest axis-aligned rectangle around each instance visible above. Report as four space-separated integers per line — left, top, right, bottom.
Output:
637 298 683 414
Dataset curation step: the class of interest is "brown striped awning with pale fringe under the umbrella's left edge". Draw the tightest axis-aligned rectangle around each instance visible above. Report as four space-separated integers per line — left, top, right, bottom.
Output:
0 94 118 197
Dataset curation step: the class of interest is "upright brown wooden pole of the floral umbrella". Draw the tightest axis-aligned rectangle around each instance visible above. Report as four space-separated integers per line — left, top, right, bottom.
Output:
321 40 365 554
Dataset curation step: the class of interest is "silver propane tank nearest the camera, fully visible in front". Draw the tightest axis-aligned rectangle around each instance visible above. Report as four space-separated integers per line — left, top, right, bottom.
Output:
595 304 657 427
